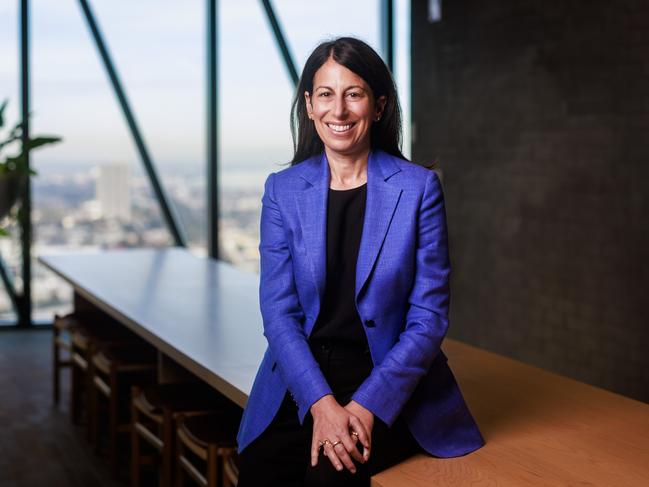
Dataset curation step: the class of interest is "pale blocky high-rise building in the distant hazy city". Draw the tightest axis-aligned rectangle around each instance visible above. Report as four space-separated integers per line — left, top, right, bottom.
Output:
97 164 131 222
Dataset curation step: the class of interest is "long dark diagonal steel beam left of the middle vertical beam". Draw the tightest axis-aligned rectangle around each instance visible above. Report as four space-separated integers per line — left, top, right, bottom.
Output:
79 0 186 247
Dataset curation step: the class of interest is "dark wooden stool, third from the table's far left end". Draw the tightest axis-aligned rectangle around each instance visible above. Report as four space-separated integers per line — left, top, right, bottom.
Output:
90 344 157 479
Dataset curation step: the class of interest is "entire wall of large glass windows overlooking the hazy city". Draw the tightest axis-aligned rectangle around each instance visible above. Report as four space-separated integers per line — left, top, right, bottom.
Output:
0 0 409 326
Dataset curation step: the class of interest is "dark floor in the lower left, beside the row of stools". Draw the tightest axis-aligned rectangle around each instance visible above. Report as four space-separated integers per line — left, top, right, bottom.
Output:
0 330 127 487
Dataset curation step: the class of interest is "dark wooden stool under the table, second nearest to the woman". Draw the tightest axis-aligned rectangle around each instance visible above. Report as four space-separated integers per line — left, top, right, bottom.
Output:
176 413 240 487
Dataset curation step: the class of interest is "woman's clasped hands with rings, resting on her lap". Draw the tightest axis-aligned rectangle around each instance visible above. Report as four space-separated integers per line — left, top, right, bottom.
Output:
311 394 373 473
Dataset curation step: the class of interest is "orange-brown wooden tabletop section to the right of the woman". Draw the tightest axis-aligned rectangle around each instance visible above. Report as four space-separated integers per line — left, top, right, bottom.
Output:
372 339 649 487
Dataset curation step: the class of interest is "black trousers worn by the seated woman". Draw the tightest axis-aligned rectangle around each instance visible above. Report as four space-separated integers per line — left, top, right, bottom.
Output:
238 343 420 487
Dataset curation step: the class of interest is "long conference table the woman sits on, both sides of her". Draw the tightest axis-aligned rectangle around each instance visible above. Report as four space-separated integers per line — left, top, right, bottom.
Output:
39 247 649 487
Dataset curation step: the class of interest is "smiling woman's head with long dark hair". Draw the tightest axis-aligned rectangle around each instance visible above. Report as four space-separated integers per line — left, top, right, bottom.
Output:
291 37 403 170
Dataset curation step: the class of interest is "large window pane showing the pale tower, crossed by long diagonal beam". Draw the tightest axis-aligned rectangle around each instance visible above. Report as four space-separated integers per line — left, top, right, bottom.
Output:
27 0 206 319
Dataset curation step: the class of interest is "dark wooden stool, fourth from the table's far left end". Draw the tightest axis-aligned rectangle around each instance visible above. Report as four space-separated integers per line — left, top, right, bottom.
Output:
131 382 238 487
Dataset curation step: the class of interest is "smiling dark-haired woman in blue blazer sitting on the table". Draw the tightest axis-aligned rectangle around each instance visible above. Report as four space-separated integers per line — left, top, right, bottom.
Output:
238 37 484 487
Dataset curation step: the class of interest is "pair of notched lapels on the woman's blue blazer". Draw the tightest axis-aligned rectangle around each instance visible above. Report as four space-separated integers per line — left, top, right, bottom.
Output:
295 150 402 320
